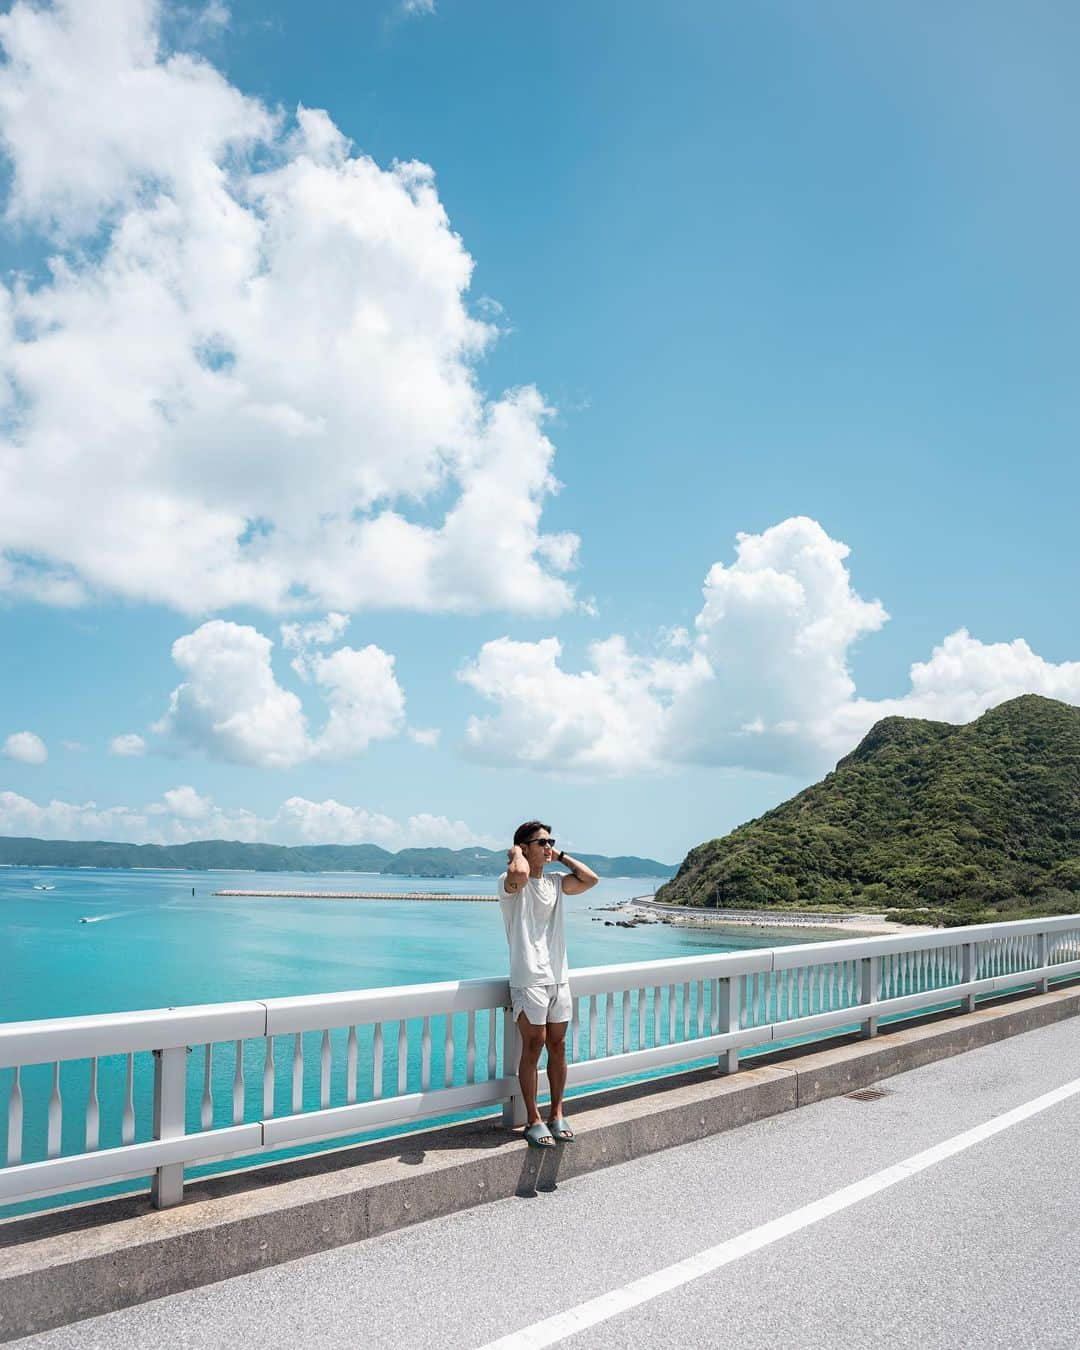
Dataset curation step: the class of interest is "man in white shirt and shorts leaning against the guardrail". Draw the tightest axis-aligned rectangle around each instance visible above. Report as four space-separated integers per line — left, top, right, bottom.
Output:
498 821 599 1149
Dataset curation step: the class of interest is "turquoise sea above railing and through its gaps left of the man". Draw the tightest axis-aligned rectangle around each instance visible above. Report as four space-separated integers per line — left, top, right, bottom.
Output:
0 868 832 1218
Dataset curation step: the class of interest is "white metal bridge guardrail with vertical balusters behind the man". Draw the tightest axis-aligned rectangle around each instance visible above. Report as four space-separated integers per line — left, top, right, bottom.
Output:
0 915 1080 1207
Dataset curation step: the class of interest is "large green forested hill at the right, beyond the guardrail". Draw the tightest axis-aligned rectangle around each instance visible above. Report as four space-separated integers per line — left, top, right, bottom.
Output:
657 694 1080 923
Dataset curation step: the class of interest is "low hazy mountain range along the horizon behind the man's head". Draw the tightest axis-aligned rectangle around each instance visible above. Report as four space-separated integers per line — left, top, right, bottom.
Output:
0 836 675 878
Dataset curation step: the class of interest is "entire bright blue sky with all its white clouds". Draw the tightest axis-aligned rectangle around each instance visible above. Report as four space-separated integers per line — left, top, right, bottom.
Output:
0 0 1080 861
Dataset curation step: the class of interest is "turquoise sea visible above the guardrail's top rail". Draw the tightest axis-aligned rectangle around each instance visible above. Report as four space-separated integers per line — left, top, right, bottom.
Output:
0 867 826 1022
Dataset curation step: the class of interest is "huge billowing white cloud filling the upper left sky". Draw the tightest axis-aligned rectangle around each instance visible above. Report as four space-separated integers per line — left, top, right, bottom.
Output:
0 0 578 614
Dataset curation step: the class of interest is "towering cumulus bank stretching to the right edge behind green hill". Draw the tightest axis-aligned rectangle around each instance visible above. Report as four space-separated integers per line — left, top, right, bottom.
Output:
460 517 1080 776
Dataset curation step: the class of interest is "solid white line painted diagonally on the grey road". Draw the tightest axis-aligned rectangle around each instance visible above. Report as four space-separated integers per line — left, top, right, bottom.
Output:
481 1079 1080 1350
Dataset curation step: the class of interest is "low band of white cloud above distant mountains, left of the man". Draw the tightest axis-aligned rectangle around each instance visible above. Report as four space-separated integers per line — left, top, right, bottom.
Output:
0 784 498 851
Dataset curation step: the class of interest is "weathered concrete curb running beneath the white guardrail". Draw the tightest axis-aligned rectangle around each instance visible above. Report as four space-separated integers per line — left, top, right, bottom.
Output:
0 984 1080 1341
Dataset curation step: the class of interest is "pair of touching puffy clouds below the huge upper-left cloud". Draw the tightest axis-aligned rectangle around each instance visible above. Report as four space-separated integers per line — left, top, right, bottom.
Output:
155 618 405 768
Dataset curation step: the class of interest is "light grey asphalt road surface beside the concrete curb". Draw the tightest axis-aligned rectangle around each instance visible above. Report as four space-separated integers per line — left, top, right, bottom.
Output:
15 1019 1080 1350
